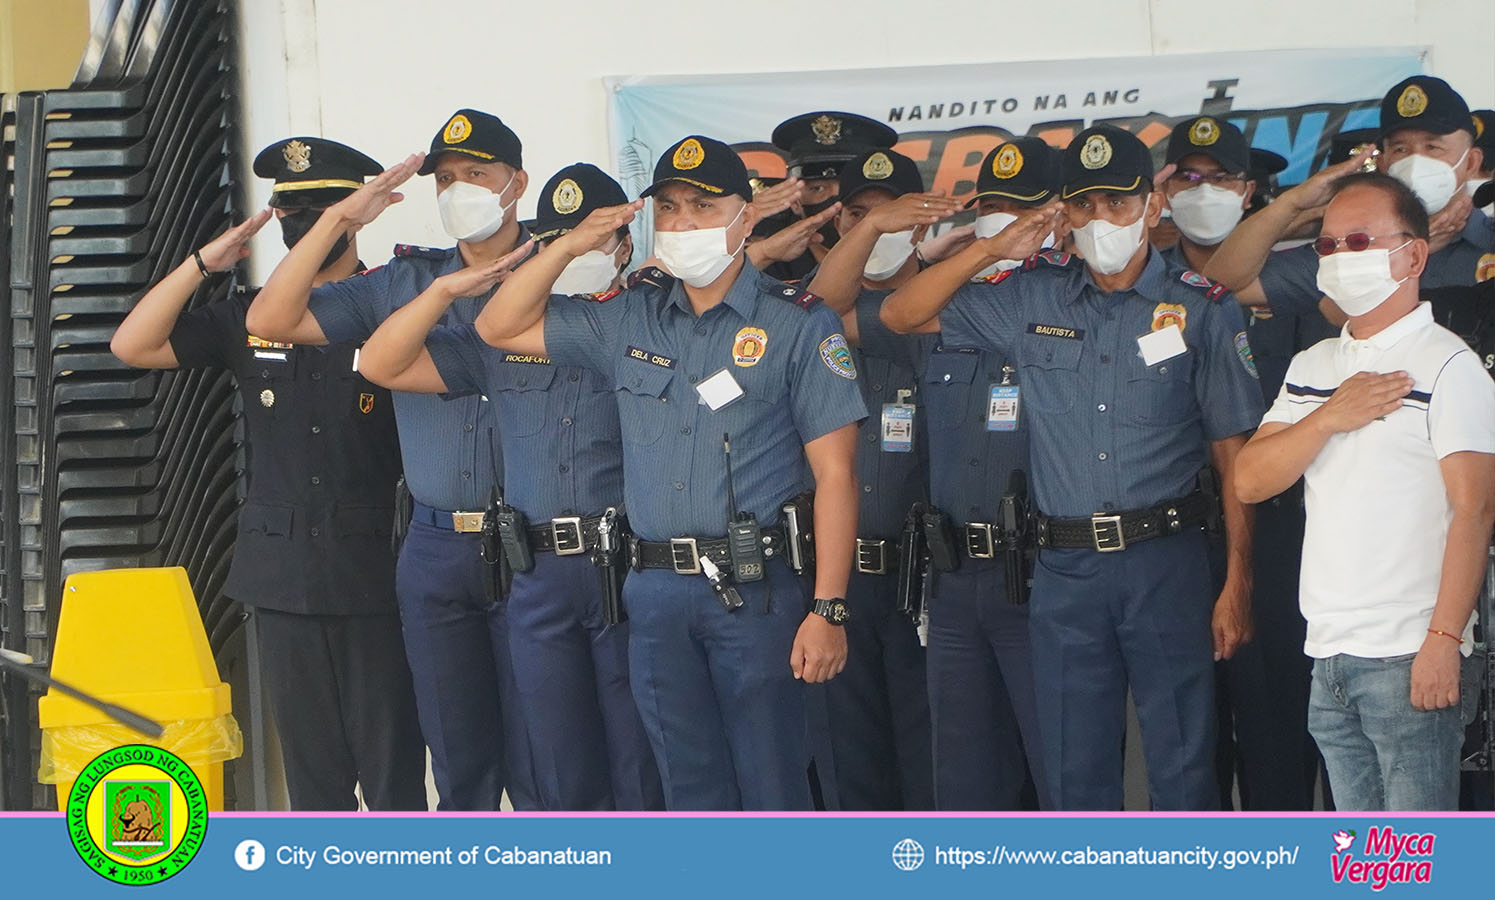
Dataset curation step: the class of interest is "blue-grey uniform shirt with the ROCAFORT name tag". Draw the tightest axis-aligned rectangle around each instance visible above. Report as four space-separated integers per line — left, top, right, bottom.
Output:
426 318 623 523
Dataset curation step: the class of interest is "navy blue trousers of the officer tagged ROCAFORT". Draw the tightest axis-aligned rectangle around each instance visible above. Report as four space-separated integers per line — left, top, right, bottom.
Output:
508 553 664 810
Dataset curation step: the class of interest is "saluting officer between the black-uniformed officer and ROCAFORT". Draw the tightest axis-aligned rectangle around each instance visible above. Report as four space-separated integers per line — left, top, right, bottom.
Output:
248 109 540 810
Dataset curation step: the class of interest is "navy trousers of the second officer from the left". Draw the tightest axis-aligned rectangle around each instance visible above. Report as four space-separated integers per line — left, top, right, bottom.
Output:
395 507 540 810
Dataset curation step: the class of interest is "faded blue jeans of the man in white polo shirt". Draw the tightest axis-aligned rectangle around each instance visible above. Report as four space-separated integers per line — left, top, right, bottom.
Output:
1308 653 1470 812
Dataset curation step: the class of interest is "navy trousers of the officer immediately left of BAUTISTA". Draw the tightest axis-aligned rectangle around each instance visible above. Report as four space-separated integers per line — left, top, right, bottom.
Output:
928 559 1051 810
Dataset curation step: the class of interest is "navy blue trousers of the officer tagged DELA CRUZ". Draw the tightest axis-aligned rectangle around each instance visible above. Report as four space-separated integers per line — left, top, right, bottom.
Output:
623 562 810 810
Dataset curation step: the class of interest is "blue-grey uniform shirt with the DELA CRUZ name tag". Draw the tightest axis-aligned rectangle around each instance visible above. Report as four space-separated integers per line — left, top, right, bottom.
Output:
544 258 867 541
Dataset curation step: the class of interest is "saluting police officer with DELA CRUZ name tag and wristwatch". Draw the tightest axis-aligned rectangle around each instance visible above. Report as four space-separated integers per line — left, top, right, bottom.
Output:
477 135 866 809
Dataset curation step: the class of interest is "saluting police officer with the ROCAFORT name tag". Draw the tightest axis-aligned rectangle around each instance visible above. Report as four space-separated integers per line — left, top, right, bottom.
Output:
352 163 664 810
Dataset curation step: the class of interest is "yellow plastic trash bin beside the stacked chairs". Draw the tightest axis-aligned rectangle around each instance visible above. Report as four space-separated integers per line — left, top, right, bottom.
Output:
37 567 244 812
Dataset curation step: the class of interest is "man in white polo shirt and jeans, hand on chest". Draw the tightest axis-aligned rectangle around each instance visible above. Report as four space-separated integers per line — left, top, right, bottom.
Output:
1235 173 1495 810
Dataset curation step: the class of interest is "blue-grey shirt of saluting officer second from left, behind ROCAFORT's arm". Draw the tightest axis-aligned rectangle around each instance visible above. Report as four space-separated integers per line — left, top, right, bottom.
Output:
309 237 529 511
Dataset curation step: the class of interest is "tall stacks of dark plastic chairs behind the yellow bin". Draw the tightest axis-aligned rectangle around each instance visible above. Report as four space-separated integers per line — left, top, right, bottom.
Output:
0 0 241 809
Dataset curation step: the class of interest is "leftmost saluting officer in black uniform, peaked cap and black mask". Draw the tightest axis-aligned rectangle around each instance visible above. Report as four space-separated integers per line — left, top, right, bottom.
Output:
111 138 426 810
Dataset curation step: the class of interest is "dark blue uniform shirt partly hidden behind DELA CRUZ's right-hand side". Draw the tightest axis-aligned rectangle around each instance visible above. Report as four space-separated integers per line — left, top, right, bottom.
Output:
855 289 934 540
